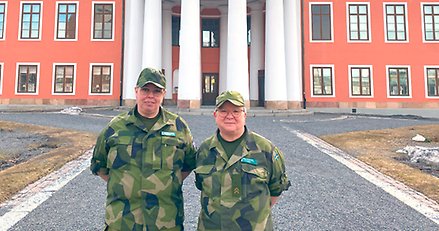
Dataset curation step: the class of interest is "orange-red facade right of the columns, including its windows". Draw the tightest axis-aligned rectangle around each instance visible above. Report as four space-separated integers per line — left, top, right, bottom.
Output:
303 0 439 108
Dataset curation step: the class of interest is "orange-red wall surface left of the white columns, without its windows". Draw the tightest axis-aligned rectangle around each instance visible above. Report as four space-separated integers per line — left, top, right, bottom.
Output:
0 0 122 103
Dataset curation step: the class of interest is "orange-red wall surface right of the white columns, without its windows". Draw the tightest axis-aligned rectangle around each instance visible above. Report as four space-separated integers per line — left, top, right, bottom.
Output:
303 0 439 107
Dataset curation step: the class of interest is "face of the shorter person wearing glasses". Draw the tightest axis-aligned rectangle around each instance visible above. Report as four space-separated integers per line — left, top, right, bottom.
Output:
213 101 247 135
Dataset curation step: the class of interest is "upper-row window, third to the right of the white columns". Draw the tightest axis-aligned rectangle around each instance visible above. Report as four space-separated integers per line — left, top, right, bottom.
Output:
385 4 407 41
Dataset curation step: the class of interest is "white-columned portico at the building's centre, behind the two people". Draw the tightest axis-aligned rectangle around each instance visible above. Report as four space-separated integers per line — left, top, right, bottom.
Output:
123 0 302 109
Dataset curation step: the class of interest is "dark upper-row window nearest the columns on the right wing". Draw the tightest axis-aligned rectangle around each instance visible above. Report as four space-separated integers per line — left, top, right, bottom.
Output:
311 4 332 41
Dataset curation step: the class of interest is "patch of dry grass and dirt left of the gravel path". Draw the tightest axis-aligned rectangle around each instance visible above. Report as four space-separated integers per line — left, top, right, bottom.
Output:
0 121 96 203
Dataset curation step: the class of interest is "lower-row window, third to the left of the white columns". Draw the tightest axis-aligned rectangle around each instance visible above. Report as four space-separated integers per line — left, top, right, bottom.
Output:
17 65 38 93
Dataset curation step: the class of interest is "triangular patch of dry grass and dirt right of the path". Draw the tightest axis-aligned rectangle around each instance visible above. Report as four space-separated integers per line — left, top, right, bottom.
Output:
321 124 439 203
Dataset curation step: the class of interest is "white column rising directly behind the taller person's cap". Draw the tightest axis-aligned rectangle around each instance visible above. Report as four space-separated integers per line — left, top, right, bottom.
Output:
142 0 162 69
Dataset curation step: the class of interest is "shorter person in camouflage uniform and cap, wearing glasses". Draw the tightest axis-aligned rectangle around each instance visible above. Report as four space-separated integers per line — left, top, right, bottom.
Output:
194 91 290 231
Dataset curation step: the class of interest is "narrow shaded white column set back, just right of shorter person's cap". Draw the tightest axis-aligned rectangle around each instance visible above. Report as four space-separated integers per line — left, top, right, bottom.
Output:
250 2 264 104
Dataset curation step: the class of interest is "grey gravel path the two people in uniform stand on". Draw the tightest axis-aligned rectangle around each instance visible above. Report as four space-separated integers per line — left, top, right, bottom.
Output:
0 112 439 231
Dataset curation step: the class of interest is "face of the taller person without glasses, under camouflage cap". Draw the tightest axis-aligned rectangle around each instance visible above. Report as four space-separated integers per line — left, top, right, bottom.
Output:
135 83 165 118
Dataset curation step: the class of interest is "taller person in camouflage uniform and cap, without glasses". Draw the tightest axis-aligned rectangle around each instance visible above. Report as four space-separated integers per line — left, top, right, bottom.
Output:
90 68 195 231
